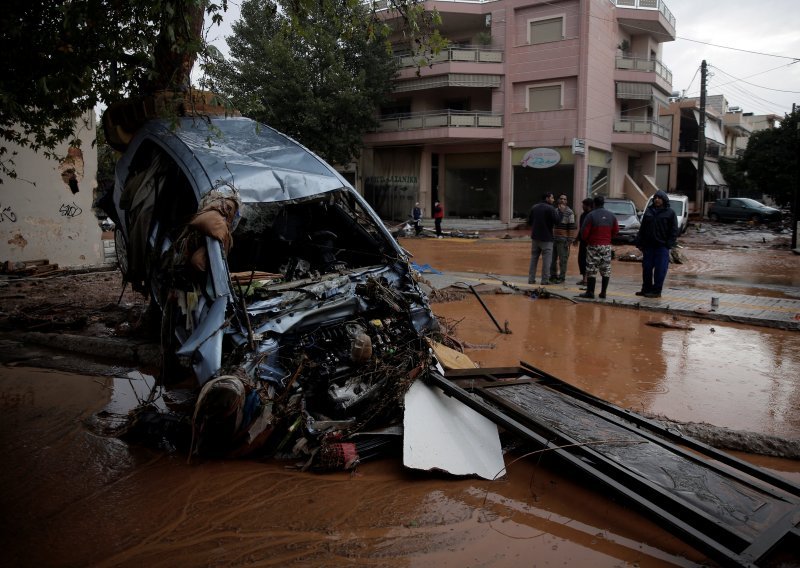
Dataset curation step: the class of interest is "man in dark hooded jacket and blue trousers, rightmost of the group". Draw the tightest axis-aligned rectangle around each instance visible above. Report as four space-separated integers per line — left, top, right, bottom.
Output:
636 189 678 298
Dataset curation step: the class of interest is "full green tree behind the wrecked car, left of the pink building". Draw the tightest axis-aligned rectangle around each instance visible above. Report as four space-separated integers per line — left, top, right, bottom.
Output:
205 0 396 164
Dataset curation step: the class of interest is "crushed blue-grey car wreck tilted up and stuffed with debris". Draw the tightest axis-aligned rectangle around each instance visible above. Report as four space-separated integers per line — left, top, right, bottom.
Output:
104 118 436 457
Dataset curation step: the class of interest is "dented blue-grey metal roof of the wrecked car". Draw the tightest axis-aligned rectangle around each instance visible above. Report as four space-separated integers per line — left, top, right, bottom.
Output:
120 117 356 203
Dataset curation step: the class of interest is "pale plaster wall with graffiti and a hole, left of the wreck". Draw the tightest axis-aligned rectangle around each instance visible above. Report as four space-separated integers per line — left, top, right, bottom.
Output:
0 112 103 266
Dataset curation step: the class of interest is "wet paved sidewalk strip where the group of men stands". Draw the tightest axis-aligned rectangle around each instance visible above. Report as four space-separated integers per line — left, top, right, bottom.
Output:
422 272 800 331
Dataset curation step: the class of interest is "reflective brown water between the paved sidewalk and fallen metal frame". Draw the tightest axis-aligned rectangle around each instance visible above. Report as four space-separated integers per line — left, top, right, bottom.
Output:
433 294 800 439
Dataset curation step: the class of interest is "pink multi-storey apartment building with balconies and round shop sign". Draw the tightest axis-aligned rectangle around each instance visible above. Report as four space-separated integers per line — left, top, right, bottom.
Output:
354 0 675 222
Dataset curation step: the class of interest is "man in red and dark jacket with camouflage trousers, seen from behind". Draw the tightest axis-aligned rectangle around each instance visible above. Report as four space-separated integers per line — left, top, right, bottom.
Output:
578 195 619 298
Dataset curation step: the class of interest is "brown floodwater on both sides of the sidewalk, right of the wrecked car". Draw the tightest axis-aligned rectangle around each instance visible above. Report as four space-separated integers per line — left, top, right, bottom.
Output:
401 235 800 439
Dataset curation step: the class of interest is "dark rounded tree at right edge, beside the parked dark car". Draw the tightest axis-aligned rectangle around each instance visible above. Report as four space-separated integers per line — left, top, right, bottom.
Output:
737 110 800 210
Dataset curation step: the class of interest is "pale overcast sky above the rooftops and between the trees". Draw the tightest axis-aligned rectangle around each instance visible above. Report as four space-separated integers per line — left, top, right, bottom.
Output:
208 0 800 116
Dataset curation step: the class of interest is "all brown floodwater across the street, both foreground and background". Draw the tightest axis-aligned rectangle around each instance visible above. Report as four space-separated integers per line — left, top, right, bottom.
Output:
0 227 800 567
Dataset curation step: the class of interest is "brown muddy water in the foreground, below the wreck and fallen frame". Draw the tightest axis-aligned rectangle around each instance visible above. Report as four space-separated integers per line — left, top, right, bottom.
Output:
0 367 720 566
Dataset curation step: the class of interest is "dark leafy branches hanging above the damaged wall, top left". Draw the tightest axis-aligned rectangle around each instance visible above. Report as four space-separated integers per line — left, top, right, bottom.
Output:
0 0 227 182
